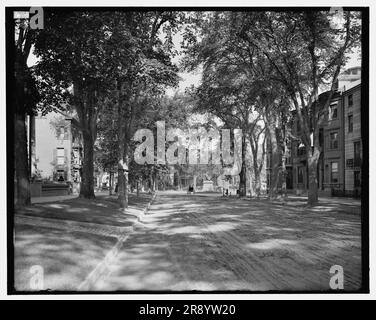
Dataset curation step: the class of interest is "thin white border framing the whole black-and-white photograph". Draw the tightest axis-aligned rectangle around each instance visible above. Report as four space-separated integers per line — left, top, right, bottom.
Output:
0 0 376 300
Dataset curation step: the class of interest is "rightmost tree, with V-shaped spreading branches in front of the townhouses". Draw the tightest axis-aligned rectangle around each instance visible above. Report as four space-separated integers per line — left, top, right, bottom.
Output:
239 11 360 205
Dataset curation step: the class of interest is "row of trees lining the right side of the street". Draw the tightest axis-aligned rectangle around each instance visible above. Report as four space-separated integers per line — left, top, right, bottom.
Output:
184 11 361 205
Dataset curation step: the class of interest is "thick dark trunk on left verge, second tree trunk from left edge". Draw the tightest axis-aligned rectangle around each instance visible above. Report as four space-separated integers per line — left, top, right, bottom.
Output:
80 132 95 199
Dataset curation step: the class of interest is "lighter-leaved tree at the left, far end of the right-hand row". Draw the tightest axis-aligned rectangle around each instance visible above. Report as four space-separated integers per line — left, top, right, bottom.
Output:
184 12 270 196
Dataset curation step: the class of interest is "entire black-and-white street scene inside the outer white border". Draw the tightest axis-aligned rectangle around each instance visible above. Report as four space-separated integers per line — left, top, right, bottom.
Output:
9 6 372 298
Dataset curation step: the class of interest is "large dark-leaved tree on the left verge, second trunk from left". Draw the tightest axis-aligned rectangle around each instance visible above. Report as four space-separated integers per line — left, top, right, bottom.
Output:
35 9 143 198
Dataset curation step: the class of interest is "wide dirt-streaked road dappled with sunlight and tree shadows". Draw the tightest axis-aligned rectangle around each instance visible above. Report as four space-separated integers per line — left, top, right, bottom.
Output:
92 193 361 291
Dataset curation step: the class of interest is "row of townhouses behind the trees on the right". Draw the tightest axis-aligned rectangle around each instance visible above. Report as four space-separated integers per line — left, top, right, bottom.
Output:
291 67 362 196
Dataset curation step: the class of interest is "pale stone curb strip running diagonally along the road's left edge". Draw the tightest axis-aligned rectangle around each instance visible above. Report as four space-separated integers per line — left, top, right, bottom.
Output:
77 193 157 291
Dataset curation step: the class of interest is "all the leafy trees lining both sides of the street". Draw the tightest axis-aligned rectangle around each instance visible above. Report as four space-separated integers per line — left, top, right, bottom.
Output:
13 9 360 208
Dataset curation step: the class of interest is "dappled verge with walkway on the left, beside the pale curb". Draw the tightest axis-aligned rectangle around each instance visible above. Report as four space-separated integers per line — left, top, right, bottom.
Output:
14 194 152 291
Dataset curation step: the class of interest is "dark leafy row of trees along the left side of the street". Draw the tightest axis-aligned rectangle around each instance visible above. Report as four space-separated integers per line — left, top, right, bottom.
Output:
14 9 184 208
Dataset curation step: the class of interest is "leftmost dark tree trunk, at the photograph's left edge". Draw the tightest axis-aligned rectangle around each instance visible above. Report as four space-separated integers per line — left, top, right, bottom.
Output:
14 112 30 206
